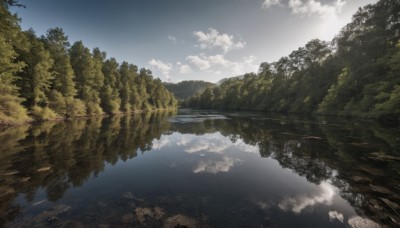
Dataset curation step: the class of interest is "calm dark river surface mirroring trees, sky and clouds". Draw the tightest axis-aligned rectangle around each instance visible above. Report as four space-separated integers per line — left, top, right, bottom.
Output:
0 110 400 227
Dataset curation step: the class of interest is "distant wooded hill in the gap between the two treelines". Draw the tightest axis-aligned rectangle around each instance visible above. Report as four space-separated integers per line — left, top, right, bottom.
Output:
164 80 215 100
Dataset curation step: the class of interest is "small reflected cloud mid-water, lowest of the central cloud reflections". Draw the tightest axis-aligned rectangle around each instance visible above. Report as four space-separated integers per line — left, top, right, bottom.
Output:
193 157 240 174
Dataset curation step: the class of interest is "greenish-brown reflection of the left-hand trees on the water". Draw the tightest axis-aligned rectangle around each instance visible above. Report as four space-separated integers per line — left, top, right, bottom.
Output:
0 112 171 227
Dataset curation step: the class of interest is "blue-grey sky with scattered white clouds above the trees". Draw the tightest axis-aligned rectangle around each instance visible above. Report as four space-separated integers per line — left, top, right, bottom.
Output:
11 0 377 82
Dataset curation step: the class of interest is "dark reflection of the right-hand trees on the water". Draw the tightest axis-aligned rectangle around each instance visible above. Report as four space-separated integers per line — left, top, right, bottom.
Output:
171 115 400 226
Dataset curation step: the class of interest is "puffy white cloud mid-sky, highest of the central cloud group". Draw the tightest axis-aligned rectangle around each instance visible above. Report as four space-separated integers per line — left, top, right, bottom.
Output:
193 28 246 52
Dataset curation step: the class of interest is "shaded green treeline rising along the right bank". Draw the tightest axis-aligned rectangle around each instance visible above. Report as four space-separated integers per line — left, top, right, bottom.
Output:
183 0 400 121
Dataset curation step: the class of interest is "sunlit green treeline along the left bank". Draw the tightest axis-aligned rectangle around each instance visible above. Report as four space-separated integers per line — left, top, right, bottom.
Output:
0 1 177 124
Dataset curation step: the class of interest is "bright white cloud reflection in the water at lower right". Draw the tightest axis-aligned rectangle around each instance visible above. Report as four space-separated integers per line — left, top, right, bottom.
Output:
279 182 335 214
